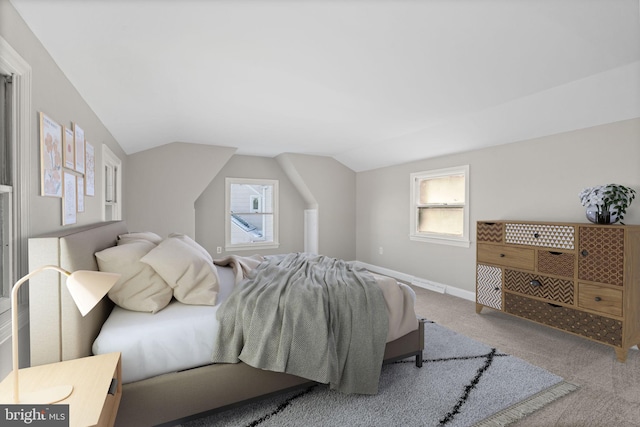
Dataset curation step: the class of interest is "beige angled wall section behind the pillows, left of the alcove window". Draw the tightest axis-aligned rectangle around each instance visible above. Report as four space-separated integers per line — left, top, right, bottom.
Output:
124 142 235 238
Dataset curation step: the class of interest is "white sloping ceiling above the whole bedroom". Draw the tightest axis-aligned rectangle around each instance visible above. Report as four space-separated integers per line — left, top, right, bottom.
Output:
11 0 640 171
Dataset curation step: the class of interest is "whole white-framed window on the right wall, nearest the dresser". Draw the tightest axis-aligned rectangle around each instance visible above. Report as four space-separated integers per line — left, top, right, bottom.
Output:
410 165 469 247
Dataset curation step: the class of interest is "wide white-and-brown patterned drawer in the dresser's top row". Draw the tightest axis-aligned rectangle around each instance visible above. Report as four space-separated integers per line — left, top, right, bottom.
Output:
505 223 575 250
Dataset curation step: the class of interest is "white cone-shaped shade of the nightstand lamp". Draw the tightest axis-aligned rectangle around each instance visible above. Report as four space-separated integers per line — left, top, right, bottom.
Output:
67 270 120 317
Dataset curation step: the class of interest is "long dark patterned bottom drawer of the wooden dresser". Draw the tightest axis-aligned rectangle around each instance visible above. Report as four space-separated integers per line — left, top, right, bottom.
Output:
505 294 622 347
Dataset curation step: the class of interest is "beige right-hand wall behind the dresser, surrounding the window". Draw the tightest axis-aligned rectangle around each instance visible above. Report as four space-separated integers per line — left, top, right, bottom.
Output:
356 119 640 292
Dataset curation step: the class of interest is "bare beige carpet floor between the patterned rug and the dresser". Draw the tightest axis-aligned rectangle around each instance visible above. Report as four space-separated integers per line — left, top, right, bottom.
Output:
415 288 640 427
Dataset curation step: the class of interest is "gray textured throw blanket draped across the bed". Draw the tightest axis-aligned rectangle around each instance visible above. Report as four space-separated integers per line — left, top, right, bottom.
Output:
212 253 389 394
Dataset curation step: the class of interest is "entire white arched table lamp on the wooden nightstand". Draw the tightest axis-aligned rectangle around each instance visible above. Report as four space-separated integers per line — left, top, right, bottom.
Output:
11 265 120 404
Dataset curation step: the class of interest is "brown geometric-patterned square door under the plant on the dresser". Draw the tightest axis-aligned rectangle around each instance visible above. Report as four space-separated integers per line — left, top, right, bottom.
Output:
578 227 624 286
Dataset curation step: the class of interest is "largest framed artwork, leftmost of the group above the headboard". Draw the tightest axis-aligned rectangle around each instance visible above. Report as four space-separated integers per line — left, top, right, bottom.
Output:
40 112 62 197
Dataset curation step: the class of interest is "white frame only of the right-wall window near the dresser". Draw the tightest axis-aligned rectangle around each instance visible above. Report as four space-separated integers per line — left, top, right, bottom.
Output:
409 165 470 248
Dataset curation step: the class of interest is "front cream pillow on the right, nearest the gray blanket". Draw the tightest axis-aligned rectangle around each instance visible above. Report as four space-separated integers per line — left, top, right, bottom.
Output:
140 237 220 305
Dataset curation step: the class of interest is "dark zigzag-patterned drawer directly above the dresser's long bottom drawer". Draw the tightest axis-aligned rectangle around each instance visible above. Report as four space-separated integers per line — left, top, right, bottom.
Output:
504 270 574 304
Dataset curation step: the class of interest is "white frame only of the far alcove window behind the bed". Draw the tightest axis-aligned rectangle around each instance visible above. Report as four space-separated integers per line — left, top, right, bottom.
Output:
224 177 280 251
